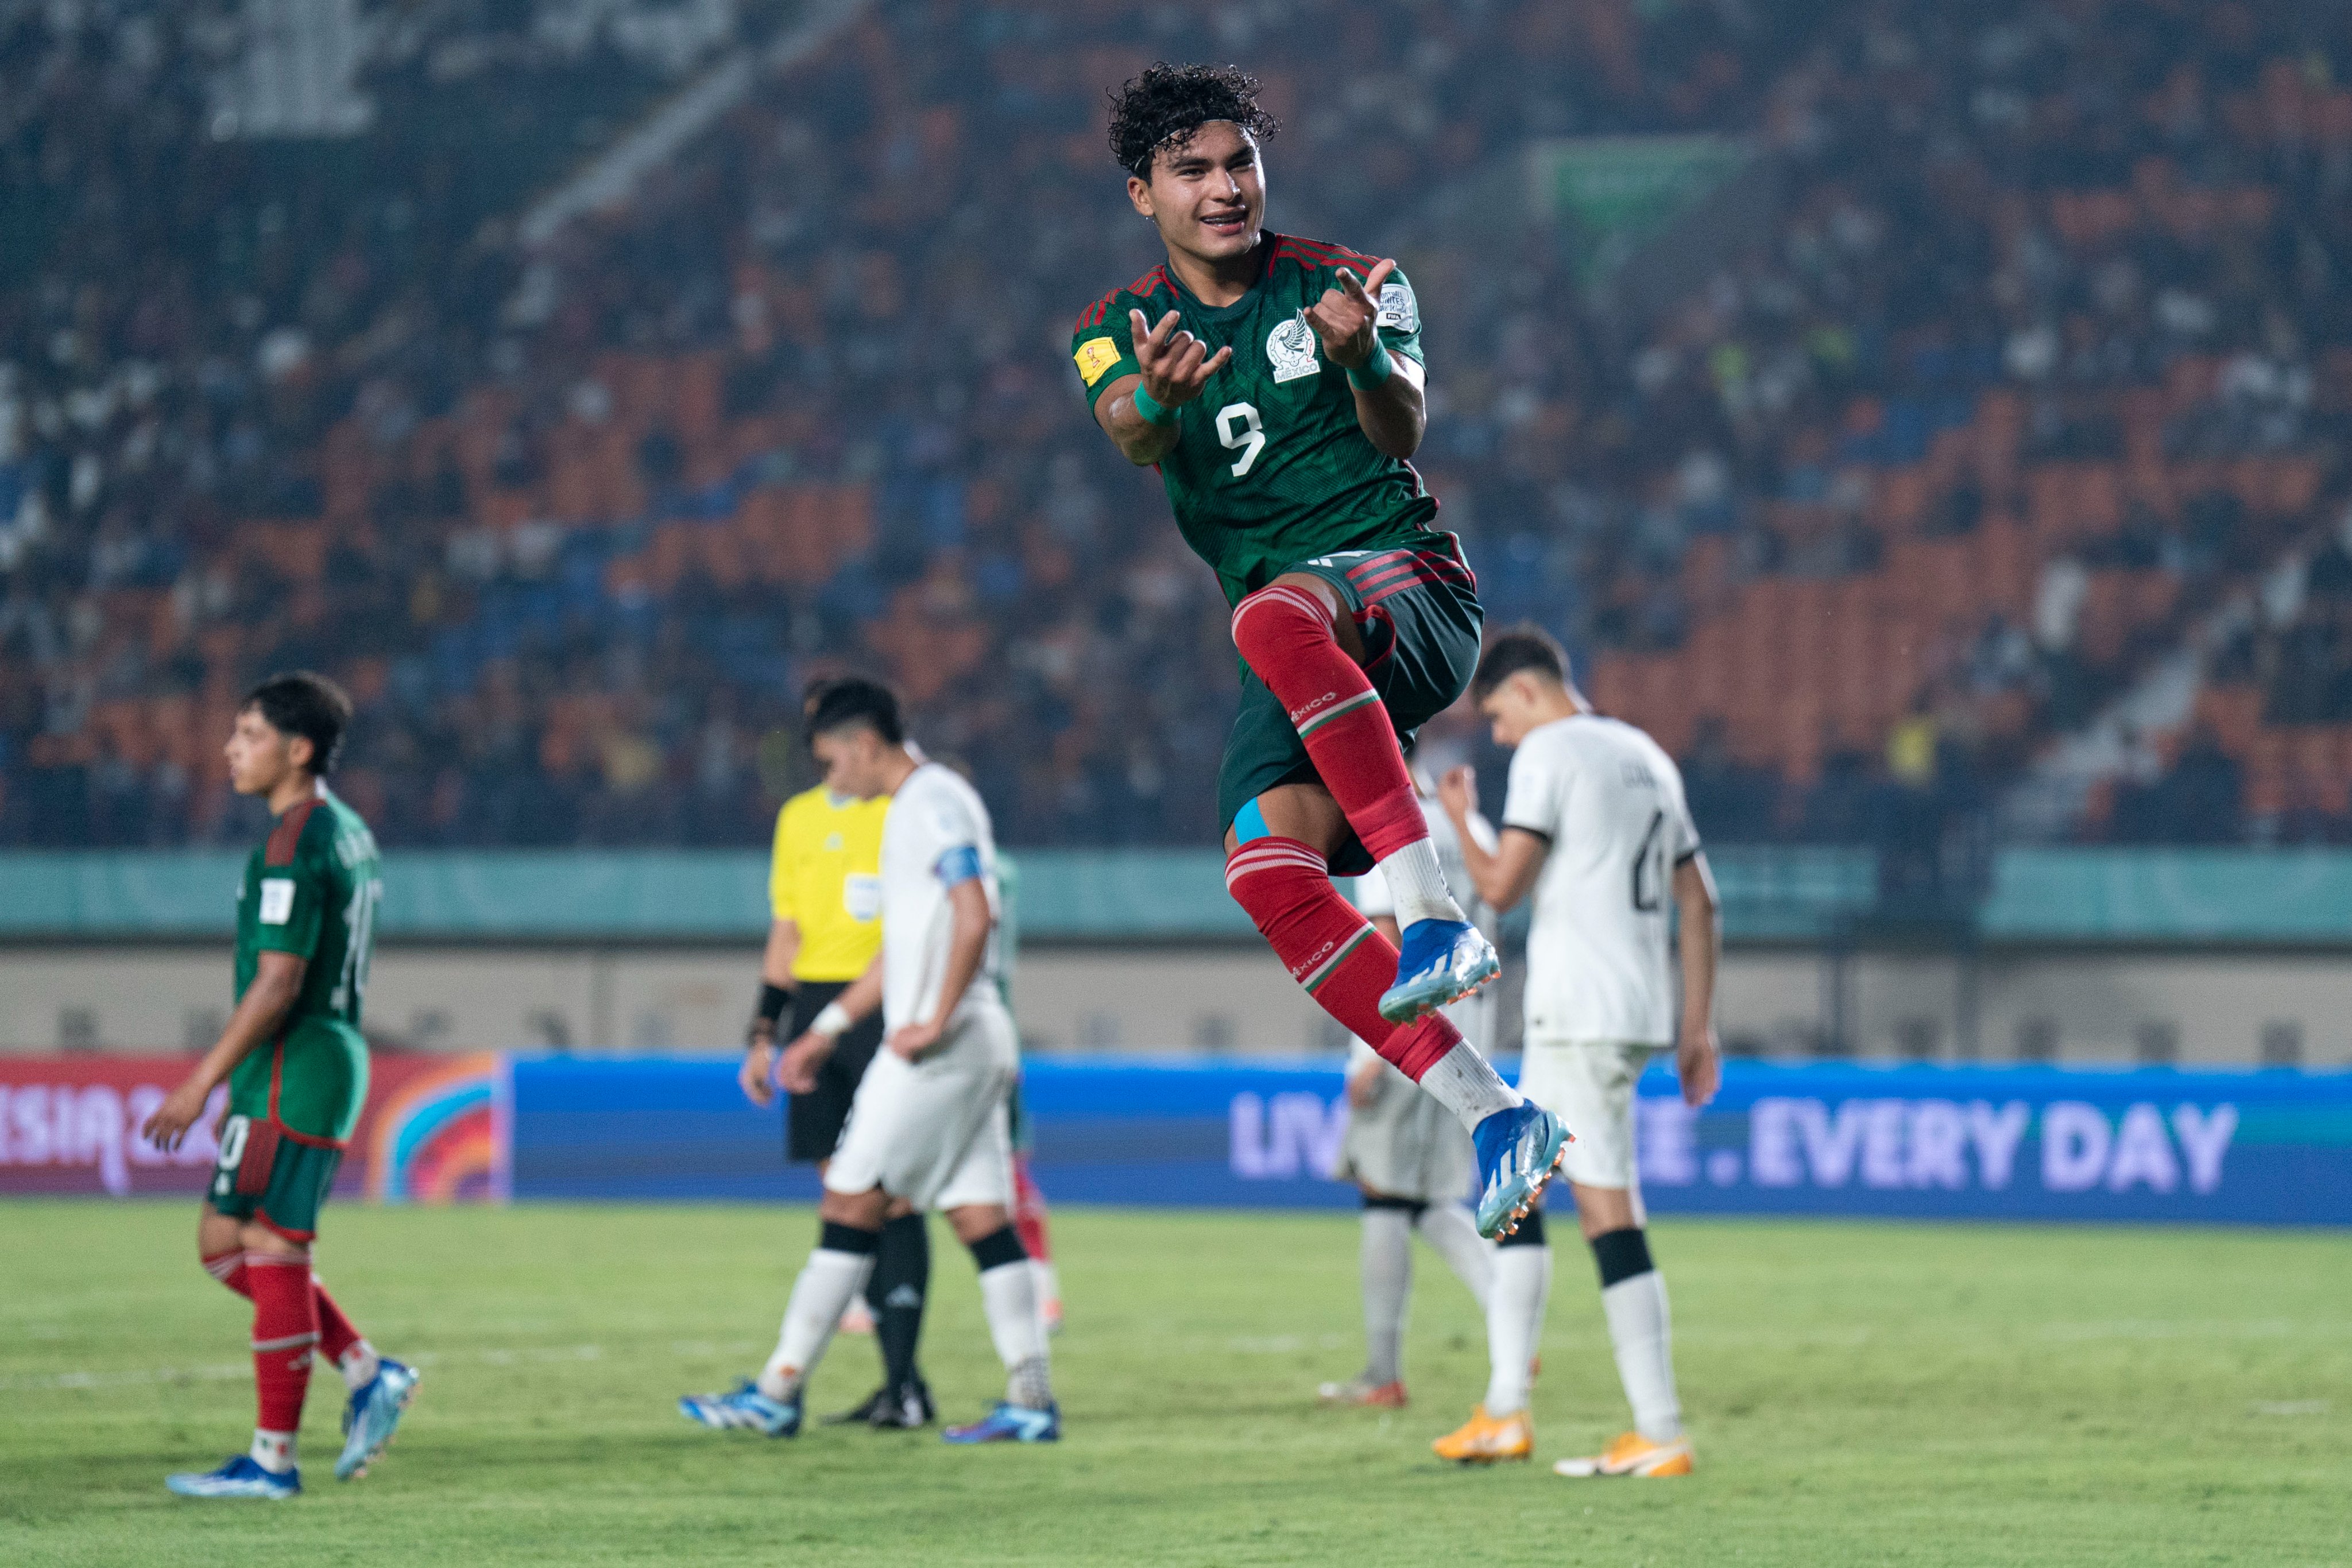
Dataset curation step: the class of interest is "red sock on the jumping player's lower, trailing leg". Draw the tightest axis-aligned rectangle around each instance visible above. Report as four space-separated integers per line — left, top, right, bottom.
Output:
1225 846 1461 1084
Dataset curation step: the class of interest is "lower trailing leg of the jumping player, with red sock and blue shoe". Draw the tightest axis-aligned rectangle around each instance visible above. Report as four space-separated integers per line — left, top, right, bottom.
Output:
1225 783 1569 1237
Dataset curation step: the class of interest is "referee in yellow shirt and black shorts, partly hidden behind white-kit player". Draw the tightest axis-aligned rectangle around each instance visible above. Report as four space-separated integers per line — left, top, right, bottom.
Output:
741 761 934 1429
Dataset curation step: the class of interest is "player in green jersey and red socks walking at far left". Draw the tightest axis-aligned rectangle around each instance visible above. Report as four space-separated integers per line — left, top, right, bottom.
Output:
141 672 416 1497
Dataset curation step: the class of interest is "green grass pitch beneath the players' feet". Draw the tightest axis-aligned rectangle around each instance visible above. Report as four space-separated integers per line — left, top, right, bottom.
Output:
0 1201 2352 1568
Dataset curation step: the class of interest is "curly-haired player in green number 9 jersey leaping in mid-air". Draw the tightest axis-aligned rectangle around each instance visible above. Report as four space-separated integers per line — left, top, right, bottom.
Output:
1070 64 1569 1237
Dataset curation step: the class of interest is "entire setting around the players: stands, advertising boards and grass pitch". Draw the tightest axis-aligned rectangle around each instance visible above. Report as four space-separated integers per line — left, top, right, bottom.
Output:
0 0 2352 1568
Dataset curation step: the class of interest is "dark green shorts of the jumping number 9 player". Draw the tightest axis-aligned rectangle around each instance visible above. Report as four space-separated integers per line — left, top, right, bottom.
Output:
1216 536 1487 877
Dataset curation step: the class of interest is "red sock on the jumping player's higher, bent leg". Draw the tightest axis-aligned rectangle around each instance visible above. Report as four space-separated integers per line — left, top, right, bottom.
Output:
1232 583 1430 865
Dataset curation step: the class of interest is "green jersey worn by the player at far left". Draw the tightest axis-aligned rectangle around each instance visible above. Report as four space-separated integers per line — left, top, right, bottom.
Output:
228 785 384 1145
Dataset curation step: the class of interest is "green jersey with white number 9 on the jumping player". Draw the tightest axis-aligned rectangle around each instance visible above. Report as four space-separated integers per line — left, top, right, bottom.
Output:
1070 233 1437 604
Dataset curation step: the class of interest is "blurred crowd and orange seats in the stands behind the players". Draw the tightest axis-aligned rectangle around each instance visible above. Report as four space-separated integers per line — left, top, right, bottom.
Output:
0 0 2352 861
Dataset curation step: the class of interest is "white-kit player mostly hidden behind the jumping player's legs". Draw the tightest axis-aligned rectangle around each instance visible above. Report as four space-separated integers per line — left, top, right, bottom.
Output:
1322 778 1494 1408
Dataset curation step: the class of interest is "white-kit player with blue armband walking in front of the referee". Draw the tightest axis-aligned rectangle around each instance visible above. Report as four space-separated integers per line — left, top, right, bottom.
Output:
678 679 1061 1443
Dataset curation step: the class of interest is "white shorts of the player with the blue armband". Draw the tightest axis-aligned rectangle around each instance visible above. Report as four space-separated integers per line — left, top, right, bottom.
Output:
826 1006 1021 1211
